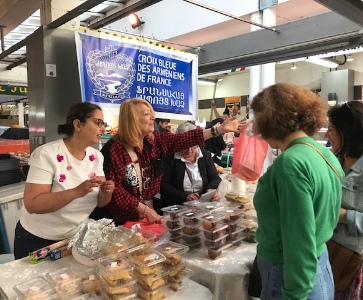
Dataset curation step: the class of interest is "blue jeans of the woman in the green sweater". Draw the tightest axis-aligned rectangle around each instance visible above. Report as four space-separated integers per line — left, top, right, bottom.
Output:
257 251 334 300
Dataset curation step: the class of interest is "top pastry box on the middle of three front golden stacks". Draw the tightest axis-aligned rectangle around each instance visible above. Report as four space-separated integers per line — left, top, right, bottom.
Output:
126 245 165 275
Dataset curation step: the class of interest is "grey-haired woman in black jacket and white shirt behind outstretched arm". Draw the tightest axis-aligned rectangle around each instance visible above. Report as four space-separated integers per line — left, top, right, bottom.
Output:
160 122 221 207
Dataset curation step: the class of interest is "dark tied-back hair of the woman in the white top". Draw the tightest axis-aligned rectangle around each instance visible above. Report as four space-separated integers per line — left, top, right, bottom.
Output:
58 102 102 136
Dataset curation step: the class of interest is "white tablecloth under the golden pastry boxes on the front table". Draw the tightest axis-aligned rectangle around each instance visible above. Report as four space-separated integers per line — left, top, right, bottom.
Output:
0 256 213 300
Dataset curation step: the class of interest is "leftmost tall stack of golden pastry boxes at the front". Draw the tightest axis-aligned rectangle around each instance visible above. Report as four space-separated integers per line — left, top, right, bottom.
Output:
97 254 136 300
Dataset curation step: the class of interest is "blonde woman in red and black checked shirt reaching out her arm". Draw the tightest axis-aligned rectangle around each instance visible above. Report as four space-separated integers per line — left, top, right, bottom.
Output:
95 98 245 224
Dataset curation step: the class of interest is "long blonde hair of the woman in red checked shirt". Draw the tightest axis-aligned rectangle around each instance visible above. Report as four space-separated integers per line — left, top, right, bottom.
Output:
113 98 155 147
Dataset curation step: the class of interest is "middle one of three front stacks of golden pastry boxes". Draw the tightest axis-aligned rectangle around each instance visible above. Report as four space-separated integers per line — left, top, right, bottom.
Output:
126 245 167 300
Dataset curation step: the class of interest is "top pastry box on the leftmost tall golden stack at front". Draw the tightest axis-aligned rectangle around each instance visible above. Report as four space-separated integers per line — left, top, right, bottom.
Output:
96 254 133 286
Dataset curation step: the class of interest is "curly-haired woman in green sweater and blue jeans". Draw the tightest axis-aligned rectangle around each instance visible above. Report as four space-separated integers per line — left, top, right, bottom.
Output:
251 83 344 300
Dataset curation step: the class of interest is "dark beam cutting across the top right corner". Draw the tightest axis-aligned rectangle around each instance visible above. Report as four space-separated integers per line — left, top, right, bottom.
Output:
314 0 363 26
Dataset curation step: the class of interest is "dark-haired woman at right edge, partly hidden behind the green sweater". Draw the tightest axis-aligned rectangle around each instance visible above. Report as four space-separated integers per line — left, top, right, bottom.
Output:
325 101 363 300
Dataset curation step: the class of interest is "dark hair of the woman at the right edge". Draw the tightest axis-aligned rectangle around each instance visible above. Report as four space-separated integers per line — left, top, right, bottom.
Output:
328 101 363 158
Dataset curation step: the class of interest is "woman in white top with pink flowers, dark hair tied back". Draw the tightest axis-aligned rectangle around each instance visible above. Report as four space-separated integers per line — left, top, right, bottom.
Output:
14 103 114 259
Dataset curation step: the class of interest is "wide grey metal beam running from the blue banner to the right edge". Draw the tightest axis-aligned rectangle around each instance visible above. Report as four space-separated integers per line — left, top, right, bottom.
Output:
191 12 363 75
